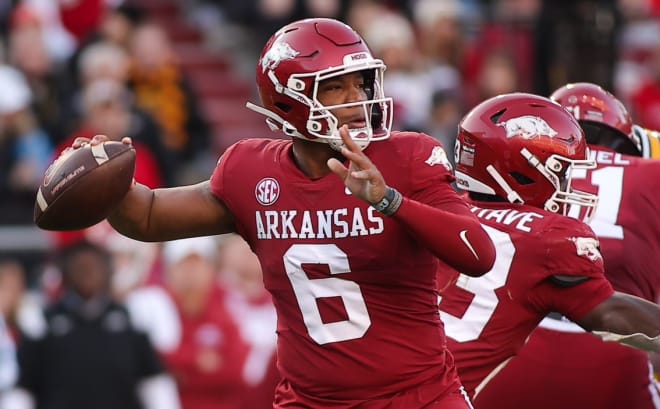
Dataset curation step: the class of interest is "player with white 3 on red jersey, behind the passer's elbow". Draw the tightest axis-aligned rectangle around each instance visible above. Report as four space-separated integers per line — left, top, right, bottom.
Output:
440 94 660 402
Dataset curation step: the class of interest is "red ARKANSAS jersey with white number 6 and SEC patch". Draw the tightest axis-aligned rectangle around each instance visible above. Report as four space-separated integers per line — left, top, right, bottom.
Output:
211 132 467 407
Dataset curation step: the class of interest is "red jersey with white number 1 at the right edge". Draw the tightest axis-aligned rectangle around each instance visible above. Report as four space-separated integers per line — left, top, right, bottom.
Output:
573 146 660 302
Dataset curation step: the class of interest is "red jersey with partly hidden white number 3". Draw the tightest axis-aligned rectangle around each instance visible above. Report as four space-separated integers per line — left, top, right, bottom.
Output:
440 202 613 395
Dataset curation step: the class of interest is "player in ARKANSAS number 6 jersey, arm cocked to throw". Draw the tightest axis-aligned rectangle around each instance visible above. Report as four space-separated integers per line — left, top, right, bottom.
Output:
63 19 495 409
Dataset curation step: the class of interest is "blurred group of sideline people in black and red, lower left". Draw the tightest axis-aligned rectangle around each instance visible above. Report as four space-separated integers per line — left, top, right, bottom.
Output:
0 224 278 409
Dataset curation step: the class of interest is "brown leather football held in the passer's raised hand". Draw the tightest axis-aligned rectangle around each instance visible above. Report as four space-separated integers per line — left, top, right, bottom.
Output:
34 141 135 231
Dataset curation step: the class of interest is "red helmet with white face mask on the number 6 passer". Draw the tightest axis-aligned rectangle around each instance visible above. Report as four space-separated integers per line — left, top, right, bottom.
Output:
247 18 393 148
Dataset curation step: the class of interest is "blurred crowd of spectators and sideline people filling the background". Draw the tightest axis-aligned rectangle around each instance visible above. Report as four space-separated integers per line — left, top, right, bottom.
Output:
0 0 660 409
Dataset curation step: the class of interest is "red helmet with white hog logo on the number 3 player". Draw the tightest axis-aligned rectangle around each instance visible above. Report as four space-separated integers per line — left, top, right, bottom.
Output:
454 93 598 218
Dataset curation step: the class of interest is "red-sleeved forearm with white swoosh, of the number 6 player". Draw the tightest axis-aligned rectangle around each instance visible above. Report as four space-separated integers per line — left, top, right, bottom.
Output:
392 198 495 277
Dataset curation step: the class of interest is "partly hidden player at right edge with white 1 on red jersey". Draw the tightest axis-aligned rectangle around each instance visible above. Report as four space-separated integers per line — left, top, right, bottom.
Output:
470 83 660 409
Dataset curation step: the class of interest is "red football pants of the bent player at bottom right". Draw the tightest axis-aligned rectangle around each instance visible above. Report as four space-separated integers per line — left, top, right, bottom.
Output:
473 328 660 409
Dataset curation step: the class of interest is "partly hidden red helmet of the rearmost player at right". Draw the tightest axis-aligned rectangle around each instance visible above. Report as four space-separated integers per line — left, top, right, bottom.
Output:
550 82 642 155
